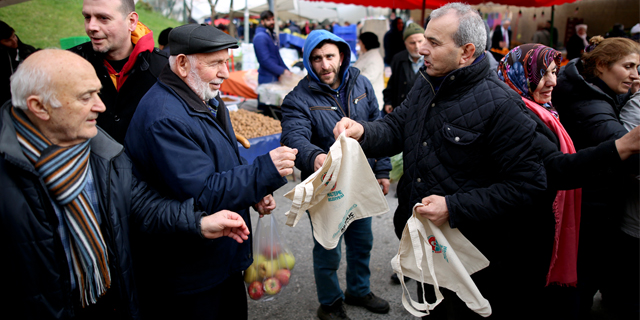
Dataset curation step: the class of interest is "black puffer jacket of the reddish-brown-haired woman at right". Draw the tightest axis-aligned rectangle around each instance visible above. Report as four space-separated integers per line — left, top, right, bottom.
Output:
552 58 640 226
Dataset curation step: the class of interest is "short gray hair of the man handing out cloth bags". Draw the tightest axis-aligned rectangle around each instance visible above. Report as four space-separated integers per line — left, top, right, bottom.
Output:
431 2 487 58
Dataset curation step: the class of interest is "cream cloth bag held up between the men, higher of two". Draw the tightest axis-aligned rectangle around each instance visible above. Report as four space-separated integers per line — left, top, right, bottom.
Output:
284 134 389 250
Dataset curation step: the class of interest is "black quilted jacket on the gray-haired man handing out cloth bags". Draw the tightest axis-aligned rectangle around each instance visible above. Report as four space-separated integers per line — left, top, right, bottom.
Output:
362 56 550 265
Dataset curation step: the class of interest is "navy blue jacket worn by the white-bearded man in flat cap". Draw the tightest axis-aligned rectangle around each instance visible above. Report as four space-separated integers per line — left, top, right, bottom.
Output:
125 66 287 298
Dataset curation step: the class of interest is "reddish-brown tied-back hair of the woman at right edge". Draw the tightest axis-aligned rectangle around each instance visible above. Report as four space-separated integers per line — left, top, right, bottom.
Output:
582 36 640 77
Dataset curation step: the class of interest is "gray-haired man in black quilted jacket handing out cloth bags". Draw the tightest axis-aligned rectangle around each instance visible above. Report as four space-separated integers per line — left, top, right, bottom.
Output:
334 3 553 319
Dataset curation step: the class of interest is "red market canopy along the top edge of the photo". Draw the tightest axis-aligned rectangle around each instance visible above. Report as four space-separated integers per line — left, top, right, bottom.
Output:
307 0 577 9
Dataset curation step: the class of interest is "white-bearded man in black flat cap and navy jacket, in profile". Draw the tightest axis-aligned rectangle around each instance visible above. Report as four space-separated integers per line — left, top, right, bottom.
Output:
125 24 297 319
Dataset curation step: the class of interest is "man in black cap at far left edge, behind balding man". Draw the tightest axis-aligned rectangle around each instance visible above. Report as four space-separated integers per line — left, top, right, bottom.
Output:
0 21 36 105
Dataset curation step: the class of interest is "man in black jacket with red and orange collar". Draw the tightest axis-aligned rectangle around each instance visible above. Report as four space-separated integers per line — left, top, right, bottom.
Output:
70 0 168 143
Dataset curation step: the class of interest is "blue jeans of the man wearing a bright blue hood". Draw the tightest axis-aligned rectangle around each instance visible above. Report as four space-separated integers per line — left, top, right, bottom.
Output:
311 217 373 305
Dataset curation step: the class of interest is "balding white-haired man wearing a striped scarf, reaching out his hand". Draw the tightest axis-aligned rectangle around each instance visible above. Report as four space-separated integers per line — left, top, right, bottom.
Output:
0 49 249 319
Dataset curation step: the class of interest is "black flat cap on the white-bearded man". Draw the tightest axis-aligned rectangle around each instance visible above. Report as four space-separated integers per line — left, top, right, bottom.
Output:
169 24 238 56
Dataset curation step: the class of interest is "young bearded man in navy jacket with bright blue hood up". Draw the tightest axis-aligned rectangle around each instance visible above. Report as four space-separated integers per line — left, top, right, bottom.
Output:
281 30 391 319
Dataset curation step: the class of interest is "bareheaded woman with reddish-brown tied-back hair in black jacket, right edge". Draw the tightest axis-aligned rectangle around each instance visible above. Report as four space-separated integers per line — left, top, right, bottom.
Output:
553 36 640 319
